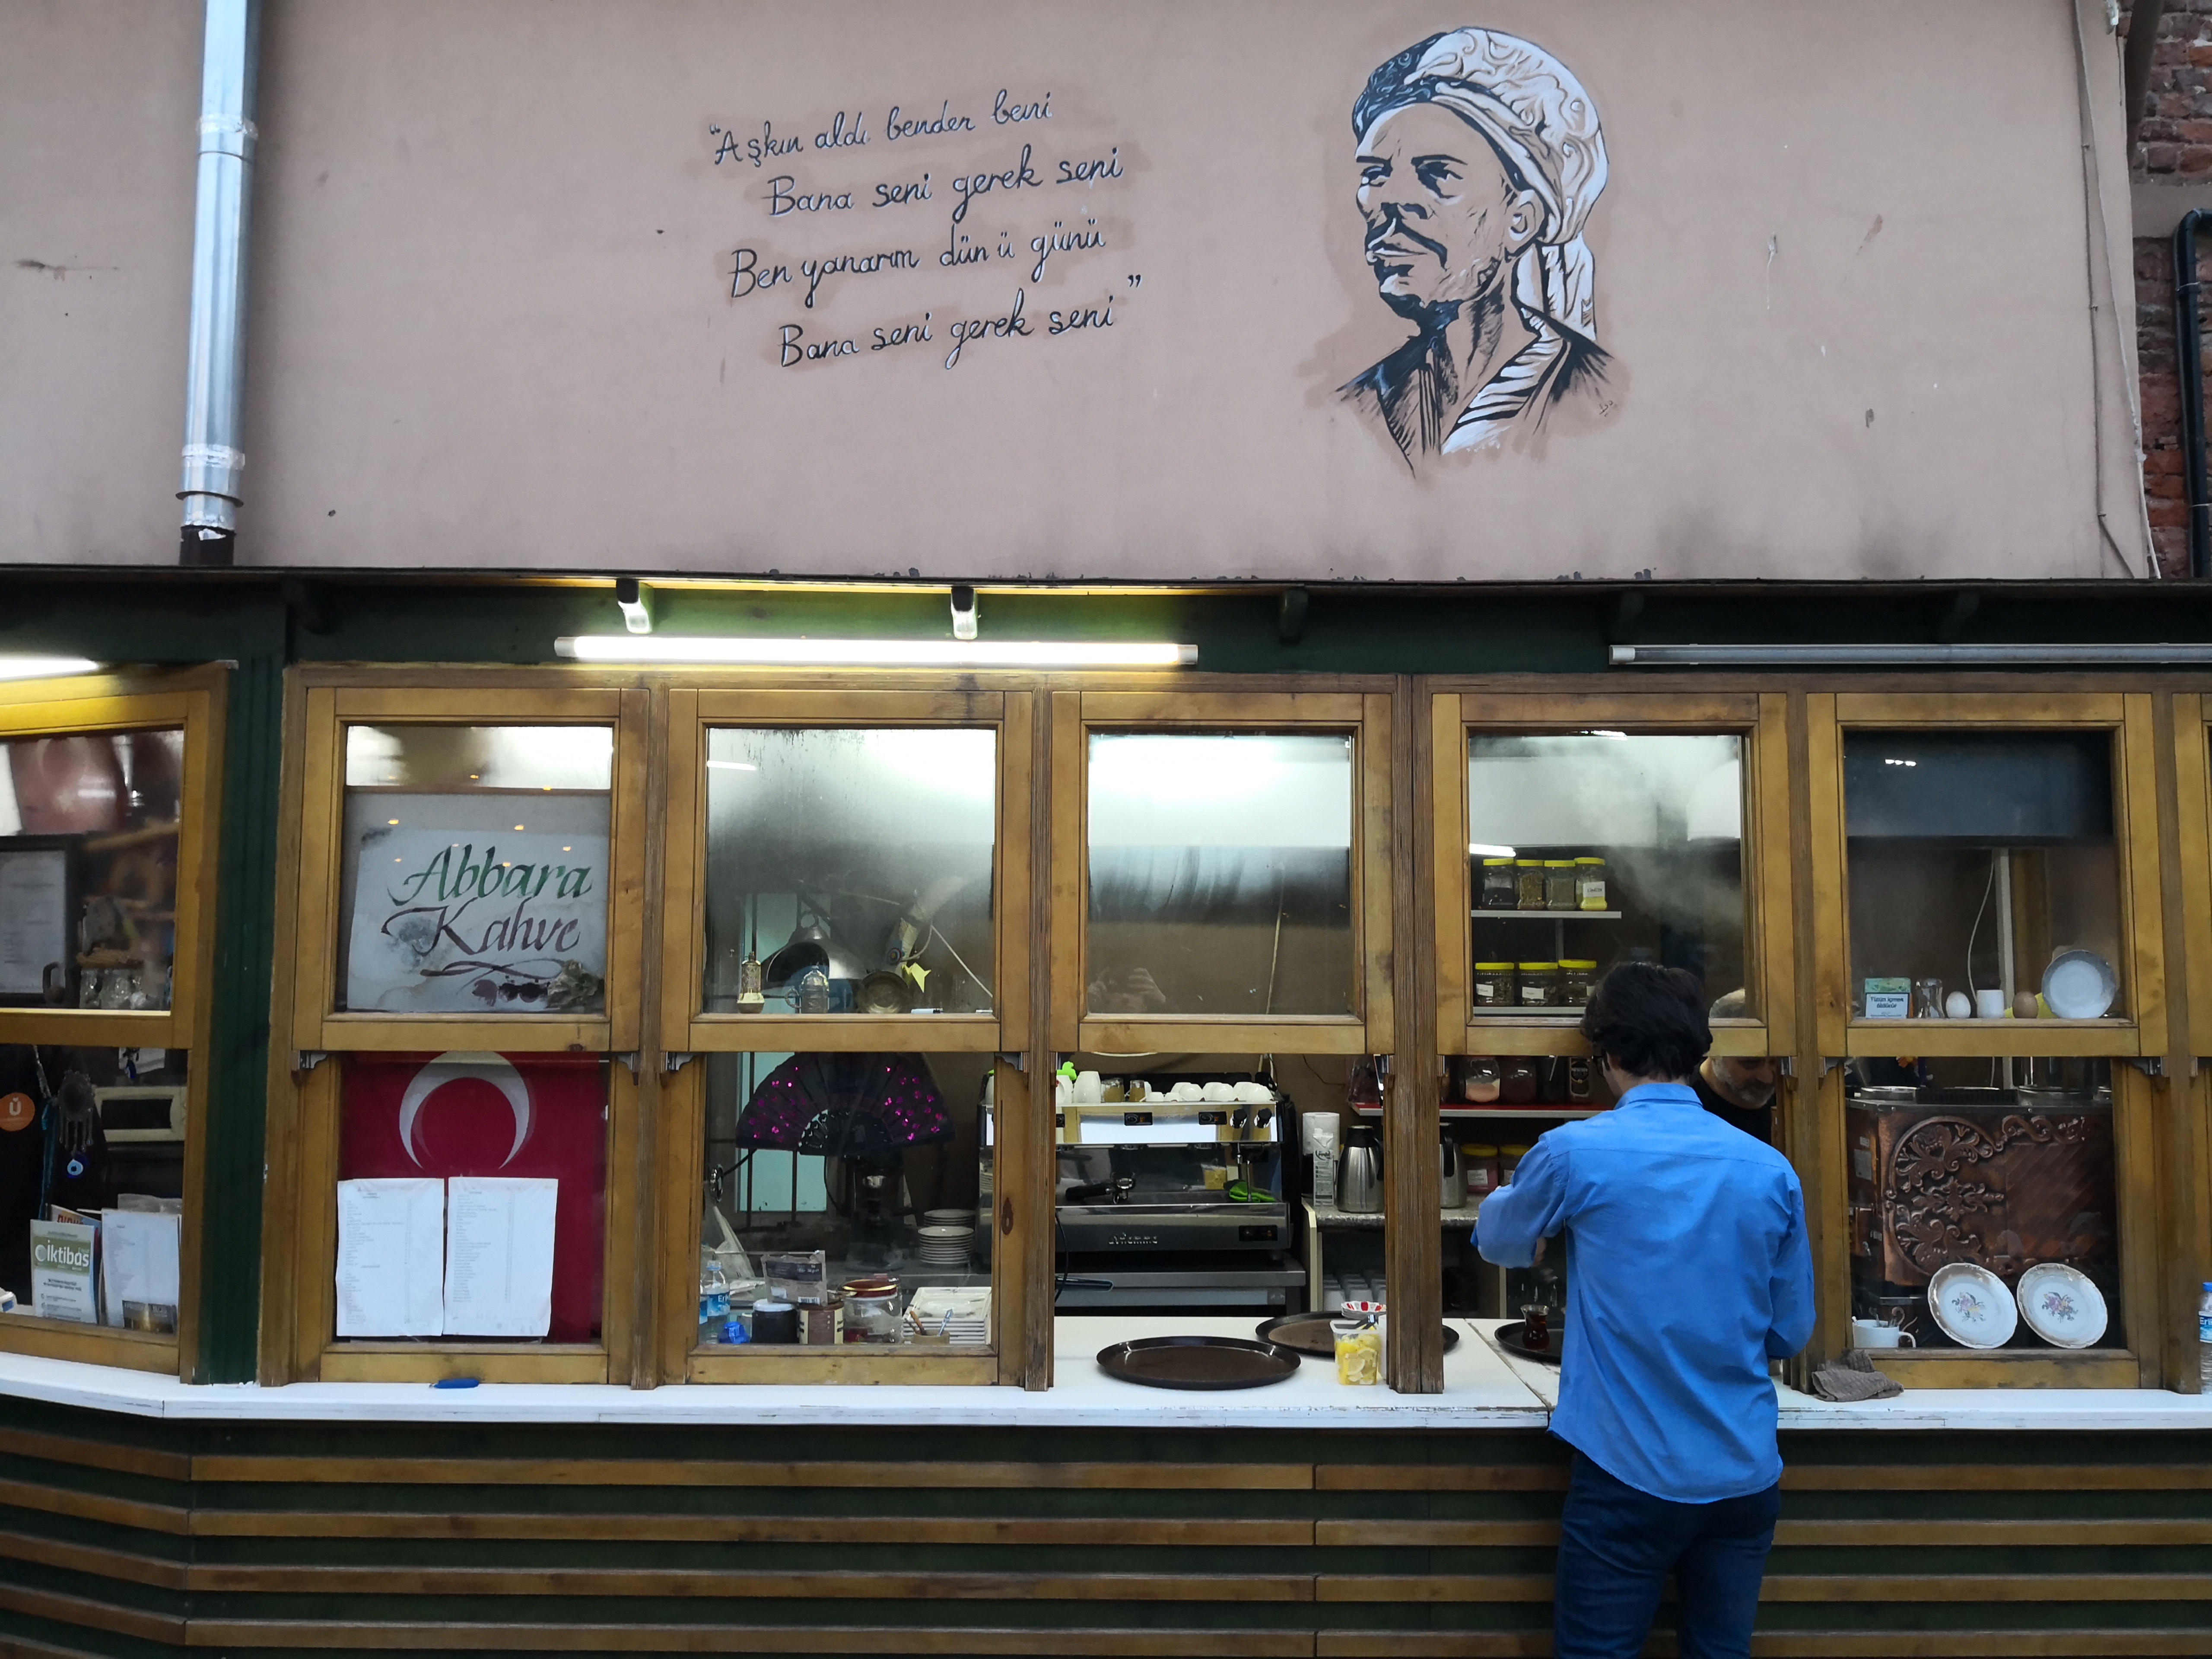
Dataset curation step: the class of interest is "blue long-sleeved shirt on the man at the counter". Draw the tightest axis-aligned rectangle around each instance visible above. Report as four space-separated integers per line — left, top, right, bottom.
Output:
1475 1084 1814 1504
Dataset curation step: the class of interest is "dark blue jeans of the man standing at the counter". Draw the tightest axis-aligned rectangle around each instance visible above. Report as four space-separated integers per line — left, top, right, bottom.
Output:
1553 1451 1783 1659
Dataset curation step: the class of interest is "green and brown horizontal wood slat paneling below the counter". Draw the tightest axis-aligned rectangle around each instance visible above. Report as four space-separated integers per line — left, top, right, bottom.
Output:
13 1411 2212 1659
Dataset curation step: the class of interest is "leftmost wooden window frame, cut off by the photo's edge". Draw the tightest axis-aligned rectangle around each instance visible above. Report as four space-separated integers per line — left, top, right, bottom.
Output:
0 666 230 1376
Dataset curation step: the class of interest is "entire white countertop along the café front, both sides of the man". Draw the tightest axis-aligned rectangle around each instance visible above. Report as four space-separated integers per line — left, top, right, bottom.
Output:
0 1314 2212 1429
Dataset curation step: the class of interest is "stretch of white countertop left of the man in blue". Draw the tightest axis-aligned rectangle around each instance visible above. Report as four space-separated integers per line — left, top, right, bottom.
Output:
0 1314 1551 1429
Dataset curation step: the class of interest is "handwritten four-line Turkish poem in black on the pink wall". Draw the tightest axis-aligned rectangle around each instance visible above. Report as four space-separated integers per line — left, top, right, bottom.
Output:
706 86 1144 374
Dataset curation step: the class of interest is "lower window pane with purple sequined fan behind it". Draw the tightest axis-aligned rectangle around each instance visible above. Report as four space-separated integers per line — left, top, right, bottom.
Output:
699 1053 993 1351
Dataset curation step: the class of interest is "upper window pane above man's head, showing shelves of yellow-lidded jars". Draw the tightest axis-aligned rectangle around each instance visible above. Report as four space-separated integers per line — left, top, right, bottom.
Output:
1467 732 1758 1022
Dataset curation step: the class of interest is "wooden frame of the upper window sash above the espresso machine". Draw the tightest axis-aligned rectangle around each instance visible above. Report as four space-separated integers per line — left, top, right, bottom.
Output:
1051 688 1389 1057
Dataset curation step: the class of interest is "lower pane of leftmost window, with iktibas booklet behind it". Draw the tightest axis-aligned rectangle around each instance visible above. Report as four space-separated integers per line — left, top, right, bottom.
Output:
0 1044 190 1336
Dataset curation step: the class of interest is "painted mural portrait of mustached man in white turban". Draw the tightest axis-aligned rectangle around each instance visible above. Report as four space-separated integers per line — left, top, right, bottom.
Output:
1343 29 1608 471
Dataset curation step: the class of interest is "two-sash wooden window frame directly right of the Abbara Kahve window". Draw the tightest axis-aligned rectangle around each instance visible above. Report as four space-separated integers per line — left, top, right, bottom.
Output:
655 683 1030 1385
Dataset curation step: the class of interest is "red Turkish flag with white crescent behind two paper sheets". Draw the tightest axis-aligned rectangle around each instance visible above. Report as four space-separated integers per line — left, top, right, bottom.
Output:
338 1053 606 1343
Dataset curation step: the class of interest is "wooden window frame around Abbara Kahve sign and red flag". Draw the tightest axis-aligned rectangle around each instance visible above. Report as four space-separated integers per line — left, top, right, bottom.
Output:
261 668 657 1382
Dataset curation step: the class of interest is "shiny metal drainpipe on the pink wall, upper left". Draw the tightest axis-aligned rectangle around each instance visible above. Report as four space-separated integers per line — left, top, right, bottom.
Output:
177 0 261 564
